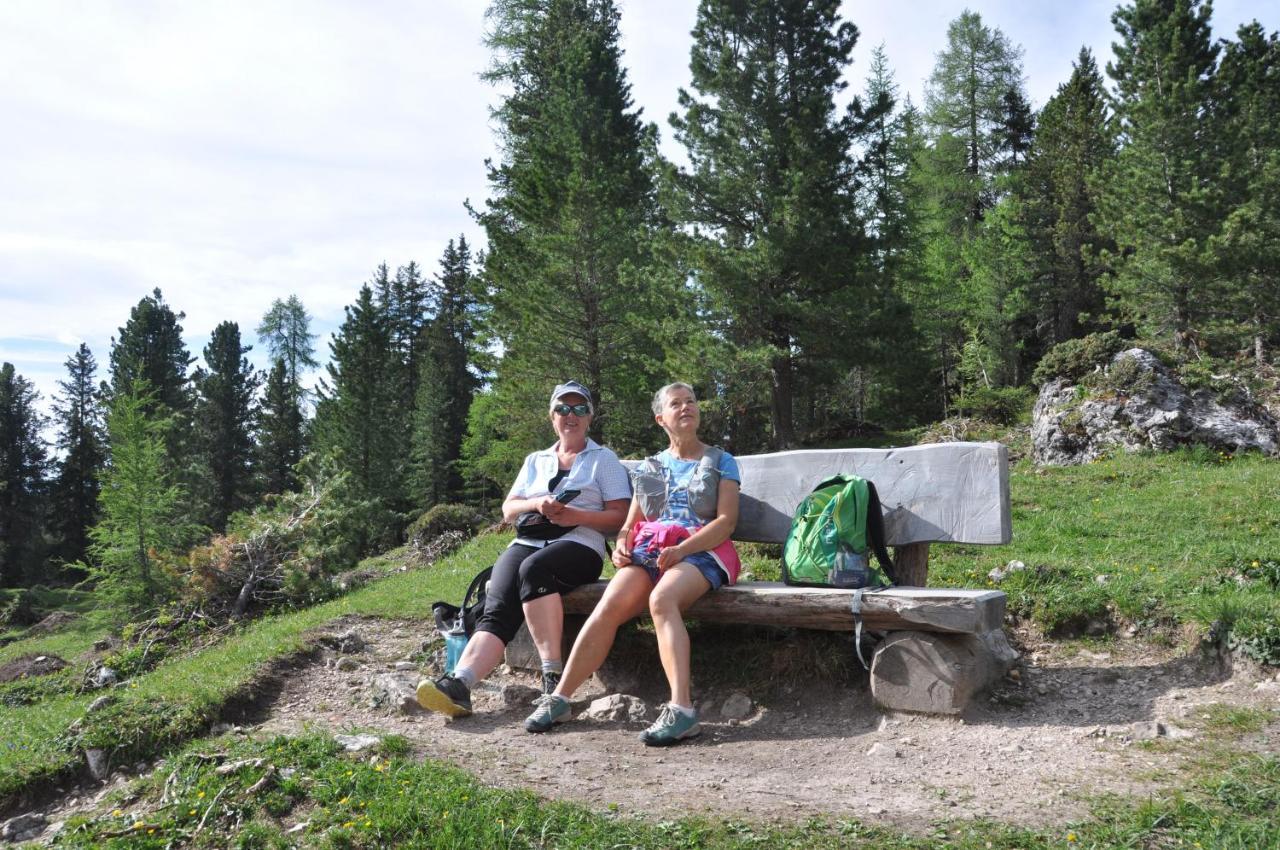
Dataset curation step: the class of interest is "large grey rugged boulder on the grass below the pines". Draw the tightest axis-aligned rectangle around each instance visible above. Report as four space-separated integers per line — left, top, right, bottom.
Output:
1032 348 1280 466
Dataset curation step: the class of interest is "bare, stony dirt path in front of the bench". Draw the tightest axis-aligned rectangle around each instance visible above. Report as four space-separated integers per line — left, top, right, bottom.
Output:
230 621 1280 830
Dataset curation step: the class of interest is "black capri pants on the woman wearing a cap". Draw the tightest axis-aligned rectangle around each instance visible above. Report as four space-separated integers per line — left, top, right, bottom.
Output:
476 540 604 644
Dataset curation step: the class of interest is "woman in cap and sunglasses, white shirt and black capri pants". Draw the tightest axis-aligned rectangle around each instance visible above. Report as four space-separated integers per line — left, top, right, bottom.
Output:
417 380 631 717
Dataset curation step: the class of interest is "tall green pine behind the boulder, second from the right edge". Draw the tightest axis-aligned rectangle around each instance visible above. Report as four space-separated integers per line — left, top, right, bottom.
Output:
1101 0 1222 355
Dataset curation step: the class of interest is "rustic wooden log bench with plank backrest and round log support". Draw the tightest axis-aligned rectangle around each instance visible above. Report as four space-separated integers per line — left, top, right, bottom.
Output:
508 443 1016 714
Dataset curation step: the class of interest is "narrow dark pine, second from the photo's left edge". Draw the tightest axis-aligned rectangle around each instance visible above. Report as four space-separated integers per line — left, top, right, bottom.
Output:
50 343 106 563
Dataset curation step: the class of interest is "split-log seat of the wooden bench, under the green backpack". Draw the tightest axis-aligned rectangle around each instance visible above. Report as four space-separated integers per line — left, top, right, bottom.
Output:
563 581 1005 634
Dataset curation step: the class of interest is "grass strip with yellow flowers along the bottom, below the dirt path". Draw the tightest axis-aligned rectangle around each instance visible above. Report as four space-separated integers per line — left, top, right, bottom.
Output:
47 735 1280 850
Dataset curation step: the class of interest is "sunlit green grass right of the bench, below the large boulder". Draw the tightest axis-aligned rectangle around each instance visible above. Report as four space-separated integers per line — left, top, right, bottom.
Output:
929 452 1280 631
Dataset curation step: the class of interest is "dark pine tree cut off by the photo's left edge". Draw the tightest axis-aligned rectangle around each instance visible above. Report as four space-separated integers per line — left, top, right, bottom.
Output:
0 362 47 588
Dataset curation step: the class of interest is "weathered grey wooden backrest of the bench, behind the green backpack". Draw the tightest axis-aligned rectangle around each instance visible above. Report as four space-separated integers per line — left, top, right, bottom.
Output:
629 443 1012 547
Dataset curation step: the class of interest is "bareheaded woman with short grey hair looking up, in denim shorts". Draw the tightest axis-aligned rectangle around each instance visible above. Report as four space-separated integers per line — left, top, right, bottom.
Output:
525 384 741 746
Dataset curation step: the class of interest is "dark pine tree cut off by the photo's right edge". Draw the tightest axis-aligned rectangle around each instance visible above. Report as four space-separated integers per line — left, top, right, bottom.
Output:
1210 22 1280 366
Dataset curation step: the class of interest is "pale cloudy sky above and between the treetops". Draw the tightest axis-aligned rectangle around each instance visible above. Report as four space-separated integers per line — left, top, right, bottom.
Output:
0 0 1280 425
